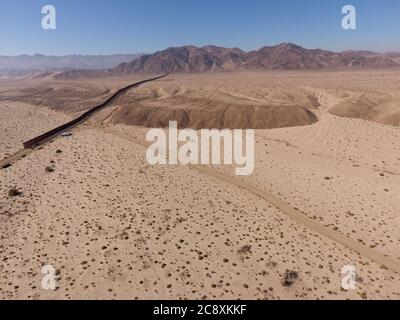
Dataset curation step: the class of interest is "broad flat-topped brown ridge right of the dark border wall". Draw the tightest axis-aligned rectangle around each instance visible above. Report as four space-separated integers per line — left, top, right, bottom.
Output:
111 86 318 129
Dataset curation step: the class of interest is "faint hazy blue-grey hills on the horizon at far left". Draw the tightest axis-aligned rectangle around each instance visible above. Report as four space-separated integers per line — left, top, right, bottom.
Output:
0 54 142 75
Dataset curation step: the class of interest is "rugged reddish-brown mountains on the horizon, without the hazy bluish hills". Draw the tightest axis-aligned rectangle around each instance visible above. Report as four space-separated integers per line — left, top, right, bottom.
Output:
57 43 400 78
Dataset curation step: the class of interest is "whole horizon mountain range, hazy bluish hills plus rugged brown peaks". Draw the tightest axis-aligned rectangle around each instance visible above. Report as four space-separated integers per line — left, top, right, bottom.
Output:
0 42 400 79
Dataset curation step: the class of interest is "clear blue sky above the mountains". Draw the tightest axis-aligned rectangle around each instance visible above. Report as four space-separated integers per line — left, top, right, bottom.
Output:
0 0 400 55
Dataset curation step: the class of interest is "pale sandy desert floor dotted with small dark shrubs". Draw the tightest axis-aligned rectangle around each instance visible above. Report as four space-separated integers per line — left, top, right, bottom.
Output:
0 71 400 299
